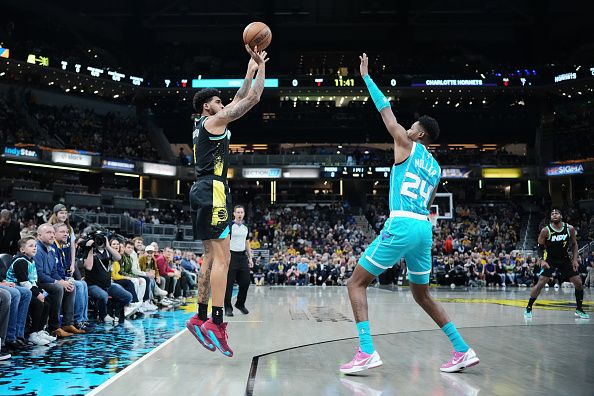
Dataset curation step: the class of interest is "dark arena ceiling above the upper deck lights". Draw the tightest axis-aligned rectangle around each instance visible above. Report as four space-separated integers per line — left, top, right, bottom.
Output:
5 0 594 72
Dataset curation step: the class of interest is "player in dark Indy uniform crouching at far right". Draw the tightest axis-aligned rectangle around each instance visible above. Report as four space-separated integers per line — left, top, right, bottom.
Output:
524 209 590 319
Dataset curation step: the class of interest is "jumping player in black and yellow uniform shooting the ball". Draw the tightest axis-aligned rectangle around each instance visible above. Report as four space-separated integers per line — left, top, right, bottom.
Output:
186 46 268 357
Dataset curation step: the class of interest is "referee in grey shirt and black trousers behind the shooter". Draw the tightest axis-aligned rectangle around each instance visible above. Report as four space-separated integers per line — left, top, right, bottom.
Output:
225 205 254 316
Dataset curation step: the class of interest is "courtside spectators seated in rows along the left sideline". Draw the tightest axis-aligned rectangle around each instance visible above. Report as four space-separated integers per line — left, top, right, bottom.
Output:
0 204 200 360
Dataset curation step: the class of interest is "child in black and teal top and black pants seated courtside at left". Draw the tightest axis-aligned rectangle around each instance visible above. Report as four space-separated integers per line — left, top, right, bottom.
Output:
6 237 56 345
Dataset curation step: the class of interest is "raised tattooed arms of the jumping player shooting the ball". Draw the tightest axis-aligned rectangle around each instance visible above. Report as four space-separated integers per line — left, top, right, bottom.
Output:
204 45 267 134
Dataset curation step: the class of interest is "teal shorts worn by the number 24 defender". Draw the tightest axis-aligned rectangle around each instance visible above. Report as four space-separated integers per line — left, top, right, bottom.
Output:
359 217 433 285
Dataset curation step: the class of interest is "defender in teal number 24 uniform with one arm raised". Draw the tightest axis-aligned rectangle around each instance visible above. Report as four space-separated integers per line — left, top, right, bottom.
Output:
340 54 479 374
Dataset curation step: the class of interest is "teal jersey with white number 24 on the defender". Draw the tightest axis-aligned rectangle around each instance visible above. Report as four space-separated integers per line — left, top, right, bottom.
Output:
390 142 441 215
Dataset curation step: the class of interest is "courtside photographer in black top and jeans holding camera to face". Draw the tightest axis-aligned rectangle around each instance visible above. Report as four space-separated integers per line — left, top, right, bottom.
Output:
80 230 132 323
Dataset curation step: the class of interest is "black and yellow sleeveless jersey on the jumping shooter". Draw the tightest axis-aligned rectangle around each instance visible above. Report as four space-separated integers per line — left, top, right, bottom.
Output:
192 116 231 179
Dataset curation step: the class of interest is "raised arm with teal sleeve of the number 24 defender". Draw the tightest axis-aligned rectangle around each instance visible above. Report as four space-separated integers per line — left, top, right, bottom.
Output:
359 53 412 148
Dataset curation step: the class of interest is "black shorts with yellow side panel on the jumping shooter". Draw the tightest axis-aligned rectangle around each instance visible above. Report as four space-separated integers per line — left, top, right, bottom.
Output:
190 177 232 241
